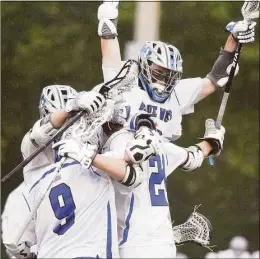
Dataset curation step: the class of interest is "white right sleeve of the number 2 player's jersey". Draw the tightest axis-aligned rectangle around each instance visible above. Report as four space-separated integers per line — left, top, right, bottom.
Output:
162 142 187 177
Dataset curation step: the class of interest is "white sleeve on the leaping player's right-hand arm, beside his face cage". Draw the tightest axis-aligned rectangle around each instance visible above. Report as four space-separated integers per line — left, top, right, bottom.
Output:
173 77 203 115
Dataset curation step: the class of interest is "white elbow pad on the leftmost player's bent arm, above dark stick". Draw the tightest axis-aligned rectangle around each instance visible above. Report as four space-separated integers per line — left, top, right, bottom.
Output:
29 116 58 147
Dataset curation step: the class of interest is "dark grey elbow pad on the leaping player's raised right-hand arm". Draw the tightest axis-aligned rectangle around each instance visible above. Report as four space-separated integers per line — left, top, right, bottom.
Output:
206 49 239 88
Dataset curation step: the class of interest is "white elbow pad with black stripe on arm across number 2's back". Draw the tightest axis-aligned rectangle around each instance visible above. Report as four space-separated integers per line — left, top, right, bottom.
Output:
119 164 144 188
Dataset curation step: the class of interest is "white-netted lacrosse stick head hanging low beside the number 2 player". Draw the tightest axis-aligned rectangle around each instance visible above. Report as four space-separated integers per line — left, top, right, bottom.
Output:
173 206 212 251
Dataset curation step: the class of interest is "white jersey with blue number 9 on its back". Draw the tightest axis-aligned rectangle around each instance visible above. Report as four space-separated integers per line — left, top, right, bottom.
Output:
24 159 118 258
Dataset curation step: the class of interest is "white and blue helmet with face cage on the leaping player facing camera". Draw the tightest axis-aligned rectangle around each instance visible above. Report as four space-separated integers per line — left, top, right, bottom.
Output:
138 41 182 103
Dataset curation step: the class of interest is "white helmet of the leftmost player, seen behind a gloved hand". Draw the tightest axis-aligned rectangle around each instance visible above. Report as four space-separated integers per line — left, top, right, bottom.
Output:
39 85 77 118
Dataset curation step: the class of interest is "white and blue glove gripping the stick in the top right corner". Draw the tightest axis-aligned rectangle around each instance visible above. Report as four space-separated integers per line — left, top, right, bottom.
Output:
226 21 256 44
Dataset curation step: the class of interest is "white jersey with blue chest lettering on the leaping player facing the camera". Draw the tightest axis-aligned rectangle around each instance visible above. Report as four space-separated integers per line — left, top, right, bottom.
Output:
103 63 203 140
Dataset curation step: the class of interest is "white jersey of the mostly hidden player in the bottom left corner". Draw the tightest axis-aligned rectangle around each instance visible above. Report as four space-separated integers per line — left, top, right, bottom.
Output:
1 183 36 254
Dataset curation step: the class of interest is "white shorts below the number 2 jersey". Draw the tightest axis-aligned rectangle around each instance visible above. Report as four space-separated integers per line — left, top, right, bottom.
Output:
119 245 176 258
